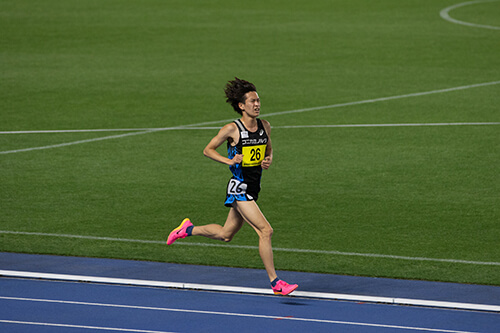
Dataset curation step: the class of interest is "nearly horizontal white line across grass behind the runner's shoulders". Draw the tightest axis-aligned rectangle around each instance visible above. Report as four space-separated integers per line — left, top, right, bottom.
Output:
0 122 500 134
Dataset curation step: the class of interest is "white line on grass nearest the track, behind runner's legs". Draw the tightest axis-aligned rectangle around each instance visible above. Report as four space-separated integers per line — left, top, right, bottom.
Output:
0 230 500 266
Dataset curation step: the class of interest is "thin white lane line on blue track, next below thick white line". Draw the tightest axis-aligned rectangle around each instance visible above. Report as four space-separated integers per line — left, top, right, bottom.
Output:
0 296 486 333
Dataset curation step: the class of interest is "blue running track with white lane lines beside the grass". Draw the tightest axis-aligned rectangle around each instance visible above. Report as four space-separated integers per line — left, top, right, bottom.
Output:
0 253 500 333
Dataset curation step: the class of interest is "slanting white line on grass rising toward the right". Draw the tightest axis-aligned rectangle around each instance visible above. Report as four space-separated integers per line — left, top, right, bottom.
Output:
0 81 500 155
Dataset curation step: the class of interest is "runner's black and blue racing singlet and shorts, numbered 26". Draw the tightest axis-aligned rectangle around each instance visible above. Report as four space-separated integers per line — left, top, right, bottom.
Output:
225 119 269 206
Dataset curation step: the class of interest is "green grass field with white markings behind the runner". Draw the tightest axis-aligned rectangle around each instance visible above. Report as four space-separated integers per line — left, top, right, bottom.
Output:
0 0 500 285
